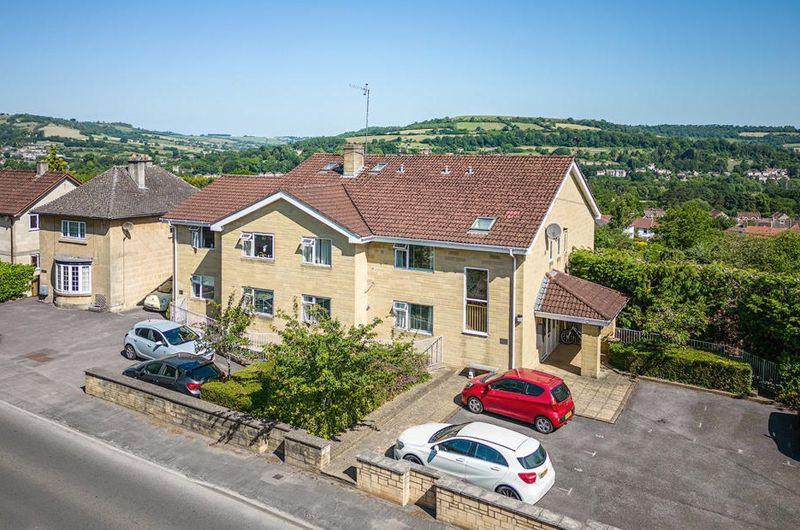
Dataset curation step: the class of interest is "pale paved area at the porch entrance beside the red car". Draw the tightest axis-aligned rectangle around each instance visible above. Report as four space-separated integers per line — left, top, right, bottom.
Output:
537 344 636 423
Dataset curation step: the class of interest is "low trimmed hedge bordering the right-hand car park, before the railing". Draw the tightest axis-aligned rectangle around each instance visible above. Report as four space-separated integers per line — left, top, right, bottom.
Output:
608 341 753 395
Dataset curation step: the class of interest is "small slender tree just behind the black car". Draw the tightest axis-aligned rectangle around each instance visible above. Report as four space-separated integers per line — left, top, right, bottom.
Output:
200 293 253 375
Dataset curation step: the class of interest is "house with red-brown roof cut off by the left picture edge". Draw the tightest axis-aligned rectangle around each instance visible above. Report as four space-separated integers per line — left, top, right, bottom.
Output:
0 162 80 293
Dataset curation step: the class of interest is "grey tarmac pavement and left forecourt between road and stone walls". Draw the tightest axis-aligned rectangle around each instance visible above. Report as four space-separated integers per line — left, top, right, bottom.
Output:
0 299 447 528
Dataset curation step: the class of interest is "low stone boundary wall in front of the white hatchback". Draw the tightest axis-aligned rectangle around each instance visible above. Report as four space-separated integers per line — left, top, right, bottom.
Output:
357 453 615 530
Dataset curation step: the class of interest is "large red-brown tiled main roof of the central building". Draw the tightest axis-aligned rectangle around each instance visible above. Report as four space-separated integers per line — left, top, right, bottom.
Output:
164 153 584 248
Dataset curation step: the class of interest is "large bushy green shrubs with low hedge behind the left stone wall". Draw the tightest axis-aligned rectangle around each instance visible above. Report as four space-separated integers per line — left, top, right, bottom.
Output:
202 311 429 438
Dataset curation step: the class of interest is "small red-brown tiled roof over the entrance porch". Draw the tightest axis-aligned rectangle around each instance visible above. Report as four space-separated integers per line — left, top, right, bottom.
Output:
536 271 628 322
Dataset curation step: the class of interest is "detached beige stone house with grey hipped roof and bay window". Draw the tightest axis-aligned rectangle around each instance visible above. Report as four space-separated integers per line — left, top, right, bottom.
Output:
35 156 197 311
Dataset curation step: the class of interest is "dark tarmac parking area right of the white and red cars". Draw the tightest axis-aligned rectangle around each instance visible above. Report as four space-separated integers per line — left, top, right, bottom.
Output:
450 381 800 529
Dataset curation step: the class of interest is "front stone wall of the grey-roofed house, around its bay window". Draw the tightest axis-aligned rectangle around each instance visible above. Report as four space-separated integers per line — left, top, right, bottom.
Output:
39 215 112 307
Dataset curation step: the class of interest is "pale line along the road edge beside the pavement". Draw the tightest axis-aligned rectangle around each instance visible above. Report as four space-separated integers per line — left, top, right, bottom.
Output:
0 400 321 530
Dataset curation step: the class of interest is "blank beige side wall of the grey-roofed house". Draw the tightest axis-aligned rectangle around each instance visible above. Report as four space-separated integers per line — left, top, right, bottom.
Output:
107 217 172 311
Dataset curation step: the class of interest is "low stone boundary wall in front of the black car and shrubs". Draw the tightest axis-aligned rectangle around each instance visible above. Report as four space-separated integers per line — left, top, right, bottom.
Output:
85 368 331 471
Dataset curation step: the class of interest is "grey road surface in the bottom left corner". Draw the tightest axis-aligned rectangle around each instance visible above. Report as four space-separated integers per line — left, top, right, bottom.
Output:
0 402 307 529
